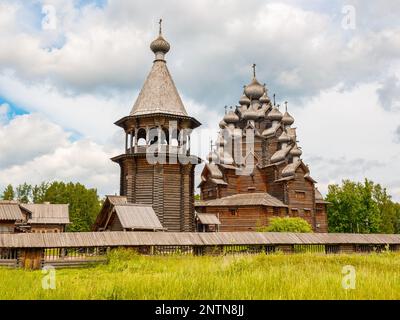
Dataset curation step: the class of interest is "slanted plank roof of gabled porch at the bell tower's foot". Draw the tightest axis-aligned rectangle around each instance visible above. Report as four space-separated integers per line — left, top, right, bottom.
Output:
114 203 164 230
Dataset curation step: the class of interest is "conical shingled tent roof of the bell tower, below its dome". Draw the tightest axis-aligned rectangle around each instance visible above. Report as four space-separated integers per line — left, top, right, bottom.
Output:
131 60 188 116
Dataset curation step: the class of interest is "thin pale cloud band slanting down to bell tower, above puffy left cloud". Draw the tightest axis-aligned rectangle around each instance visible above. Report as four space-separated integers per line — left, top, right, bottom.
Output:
0 74 128 143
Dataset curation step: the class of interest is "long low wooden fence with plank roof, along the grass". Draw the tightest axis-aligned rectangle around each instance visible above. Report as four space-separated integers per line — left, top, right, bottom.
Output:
0 232 400 269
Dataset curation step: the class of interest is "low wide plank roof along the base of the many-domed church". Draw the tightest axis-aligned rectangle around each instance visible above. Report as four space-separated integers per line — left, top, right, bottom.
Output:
195 192 287 207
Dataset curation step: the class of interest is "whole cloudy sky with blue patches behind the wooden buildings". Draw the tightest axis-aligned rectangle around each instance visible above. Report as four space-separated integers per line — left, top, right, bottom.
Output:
0 0 400 201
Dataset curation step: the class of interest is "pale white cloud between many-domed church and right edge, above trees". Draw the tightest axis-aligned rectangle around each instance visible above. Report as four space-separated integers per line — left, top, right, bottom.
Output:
289 84 400 200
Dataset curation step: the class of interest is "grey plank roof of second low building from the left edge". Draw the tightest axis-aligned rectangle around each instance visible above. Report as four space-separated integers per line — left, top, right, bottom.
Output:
20 203 70 224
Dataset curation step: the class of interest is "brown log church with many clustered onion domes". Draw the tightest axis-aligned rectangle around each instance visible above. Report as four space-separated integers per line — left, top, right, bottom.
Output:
196 65 327 232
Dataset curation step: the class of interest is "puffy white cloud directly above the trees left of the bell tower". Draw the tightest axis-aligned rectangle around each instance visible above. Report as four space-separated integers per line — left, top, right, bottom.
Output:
0 114 119 195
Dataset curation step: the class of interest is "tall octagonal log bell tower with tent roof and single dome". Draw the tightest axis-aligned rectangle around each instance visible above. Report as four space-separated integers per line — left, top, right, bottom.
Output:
112 21 200 232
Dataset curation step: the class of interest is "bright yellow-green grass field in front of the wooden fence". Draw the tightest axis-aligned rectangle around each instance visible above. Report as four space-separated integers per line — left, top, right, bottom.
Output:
0 251 400 299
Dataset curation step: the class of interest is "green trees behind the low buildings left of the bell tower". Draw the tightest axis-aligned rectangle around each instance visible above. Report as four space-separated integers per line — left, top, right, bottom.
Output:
1 181 102 232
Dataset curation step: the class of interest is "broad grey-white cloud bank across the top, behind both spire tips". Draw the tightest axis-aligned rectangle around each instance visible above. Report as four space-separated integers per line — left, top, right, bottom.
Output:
0 0 400 104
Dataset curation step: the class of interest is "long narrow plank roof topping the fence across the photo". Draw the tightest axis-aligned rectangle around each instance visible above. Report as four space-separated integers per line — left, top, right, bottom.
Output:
0 231 400 248
